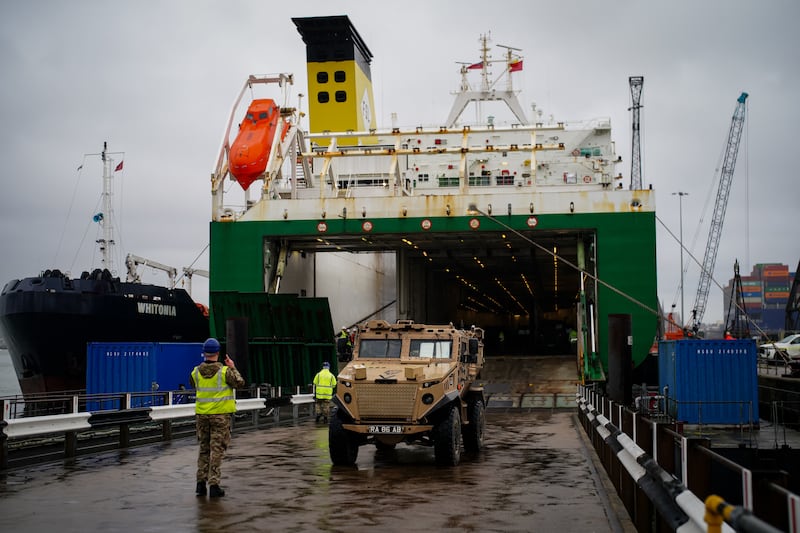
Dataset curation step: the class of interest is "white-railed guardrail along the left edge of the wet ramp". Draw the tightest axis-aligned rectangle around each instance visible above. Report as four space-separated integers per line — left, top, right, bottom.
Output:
0 385 315 470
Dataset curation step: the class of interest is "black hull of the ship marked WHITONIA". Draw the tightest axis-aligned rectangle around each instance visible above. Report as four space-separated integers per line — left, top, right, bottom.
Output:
0 270 209 395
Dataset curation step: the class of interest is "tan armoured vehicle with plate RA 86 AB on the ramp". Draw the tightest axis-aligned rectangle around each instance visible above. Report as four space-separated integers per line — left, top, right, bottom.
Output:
328 320 486 466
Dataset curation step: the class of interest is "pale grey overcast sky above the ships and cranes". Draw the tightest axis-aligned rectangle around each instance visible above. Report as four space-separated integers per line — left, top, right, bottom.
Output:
0 0 800 322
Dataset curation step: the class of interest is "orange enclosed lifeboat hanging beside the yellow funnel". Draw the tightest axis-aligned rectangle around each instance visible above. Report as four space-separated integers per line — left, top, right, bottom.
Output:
228 99 289 190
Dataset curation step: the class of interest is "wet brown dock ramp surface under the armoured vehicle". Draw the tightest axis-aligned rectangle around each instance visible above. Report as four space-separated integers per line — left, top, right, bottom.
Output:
0 409 633 533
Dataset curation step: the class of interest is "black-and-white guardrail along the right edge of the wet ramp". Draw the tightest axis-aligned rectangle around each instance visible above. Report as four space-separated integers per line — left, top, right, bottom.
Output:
576 386 800 533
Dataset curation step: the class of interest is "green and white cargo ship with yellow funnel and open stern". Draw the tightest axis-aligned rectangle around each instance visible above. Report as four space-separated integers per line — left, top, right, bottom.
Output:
209 15 659 386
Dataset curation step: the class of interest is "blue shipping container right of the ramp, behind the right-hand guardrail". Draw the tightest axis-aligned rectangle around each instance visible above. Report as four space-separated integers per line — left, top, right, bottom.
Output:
658 339 759 425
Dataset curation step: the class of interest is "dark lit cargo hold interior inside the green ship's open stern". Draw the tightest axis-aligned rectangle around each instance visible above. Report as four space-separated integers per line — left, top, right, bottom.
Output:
276 224 594 355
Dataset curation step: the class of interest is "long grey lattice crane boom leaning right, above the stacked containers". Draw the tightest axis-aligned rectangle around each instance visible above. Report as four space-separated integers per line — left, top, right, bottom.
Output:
691 92 748 334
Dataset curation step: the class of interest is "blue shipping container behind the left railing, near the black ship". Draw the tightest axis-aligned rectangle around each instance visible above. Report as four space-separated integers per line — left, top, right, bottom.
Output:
86 342 203 411
